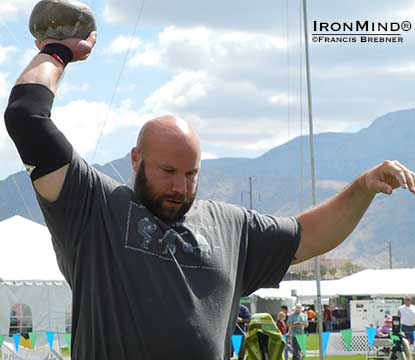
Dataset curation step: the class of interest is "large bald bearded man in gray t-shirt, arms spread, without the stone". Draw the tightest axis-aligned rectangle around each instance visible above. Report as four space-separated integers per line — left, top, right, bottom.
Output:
5 33 415 360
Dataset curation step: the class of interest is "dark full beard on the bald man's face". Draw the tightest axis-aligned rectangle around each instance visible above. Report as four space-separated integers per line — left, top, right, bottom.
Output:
134 160 197 222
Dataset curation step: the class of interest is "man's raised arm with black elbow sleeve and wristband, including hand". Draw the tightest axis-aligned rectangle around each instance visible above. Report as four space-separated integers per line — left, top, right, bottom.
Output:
4 32 96 202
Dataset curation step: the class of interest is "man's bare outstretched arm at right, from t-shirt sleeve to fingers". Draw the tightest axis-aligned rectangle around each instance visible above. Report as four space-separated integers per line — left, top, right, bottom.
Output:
294 161 415 263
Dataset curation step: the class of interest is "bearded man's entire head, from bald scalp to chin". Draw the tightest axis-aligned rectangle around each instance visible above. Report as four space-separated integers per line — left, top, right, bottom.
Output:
131 115 201 221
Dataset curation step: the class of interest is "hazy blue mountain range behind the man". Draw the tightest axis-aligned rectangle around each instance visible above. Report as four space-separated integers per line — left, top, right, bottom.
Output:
0 109 415 267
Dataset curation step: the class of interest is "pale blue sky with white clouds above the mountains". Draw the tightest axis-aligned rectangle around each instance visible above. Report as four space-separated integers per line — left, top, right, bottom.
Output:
0 0 415 179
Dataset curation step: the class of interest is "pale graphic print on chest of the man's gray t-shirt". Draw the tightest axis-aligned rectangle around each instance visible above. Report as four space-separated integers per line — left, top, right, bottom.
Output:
124 201 220 267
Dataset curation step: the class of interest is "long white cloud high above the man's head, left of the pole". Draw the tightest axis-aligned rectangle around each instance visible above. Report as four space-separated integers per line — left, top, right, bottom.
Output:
129 26 295 76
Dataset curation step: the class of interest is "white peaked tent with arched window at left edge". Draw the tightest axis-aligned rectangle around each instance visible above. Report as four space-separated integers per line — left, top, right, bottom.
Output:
0 216 72 335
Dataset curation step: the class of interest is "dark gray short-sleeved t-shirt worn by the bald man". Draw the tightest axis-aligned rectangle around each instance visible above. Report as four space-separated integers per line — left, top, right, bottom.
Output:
38 152 300 360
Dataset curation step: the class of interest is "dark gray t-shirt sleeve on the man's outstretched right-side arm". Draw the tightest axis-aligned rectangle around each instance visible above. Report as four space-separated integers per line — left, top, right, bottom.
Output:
243 211 301 296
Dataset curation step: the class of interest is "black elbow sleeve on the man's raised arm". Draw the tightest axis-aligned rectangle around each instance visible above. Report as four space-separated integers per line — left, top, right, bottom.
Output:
4 84 72 181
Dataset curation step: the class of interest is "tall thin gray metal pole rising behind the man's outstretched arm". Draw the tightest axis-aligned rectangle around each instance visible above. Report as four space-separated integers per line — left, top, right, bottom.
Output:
303 0 323 360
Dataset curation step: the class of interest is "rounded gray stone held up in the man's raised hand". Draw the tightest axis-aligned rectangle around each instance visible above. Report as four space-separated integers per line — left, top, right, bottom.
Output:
29 0 96 41
